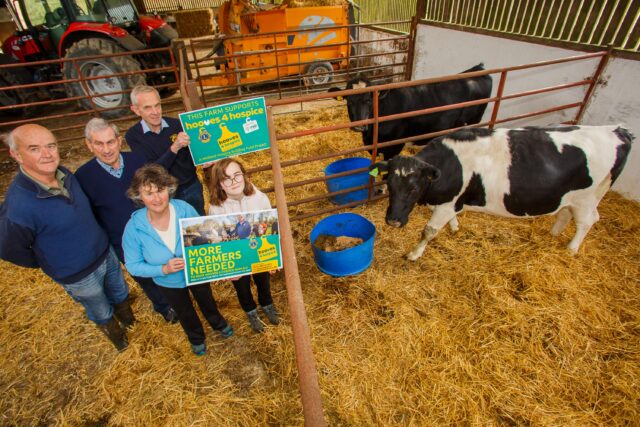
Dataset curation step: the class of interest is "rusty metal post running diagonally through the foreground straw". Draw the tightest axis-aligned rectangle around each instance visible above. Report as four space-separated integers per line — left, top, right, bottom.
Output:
267 107 326 427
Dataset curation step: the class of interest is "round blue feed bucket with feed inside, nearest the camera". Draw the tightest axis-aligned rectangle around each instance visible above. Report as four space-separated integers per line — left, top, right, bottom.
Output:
310 212 376 277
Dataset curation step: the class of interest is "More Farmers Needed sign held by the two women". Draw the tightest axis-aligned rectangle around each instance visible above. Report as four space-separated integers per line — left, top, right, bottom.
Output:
180 209 282 285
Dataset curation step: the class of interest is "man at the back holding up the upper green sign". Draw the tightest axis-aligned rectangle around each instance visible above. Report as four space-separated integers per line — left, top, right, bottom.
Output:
125 86 206 216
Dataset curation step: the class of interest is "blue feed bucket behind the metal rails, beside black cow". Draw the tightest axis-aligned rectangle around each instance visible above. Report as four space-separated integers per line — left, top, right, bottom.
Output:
324 157 371 205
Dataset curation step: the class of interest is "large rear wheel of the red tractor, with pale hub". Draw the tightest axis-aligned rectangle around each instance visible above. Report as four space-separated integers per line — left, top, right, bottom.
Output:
62 38 145 118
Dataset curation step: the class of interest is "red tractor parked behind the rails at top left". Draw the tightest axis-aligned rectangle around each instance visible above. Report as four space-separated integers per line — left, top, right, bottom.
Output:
0 0 178 118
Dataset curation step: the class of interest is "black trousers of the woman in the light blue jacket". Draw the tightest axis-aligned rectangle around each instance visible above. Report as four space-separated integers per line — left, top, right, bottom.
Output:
159 283 228 345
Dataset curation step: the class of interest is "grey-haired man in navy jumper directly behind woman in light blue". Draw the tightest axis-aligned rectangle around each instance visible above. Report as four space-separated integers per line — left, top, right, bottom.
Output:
75 118 178 323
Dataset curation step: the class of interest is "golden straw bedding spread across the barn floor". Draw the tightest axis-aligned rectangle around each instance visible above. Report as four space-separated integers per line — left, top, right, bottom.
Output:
0 103 640 426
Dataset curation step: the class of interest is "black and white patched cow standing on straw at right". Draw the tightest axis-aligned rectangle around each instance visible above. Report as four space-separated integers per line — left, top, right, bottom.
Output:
371 126 634 261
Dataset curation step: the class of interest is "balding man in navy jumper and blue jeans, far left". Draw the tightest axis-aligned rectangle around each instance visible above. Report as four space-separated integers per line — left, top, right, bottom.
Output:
0 124 135 350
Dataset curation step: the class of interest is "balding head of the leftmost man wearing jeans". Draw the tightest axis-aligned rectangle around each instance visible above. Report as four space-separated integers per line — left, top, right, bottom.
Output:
10 125 60 179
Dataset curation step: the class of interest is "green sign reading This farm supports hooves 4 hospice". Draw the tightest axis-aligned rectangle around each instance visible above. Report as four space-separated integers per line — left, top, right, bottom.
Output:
180 98 269 166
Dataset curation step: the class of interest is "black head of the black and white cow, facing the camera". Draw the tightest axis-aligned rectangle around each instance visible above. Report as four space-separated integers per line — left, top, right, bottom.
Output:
370 156 440 227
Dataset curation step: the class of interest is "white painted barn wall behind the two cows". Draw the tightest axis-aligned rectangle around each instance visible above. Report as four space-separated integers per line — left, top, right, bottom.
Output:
413 25 640 201
